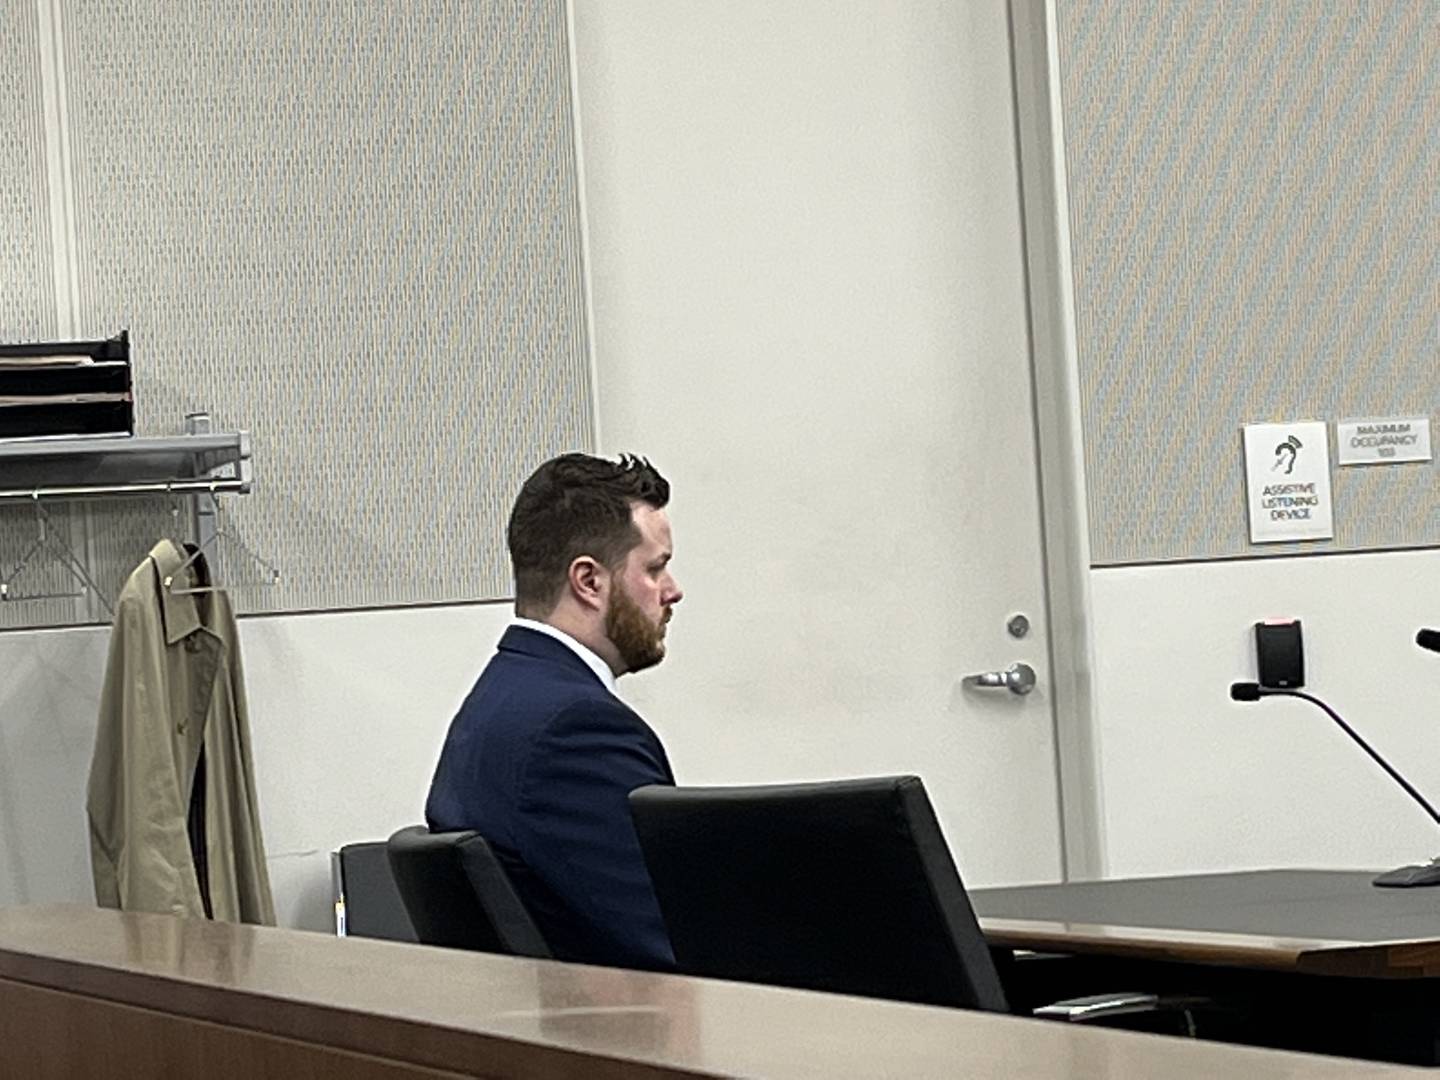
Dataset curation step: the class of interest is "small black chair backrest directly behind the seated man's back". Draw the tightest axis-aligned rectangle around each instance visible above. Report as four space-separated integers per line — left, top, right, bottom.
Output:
386 825 550 958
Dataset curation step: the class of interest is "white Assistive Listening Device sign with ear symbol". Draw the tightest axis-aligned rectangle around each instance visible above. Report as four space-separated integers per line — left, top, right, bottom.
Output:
1244 420 1335 544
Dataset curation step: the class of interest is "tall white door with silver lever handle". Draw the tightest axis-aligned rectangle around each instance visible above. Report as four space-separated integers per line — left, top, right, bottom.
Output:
572 0 1061 886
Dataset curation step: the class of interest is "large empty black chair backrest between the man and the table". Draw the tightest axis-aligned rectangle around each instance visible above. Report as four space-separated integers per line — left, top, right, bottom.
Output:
629 776 1008 1012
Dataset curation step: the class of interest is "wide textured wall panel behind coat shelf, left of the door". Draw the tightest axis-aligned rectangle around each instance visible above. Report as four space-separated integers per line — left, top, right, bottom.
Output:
42 0 593 624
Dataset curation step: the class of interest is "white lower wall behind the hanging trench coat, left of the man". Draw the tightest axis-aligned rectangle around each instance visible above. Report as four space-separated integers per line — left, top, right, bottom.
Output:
0 605 510 930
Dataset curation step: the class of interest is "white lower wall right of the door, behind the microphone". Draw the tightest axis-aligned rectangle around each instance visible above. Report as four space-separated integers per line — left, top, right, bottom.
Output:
1092 552 1440 877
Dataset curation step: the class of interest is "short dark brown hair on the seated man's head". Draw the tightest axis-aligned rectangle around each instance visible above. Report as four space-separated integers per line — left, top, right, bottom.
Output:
505 454 670 618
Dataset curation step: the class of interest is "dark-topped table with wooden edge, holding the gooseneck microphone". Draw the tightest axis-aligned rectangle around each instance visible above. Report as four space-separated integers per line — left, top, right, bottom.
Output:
971 870 1440 1064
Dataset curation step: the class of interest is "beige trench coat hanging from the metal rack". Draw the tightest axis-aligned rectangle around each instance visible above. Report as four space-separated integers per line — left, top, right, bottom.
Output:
86 540 275 924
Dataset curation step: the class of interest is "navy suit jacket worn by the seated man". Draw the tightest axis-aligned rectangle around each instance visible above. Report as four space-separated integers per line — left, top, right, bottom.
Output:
425 626 675 969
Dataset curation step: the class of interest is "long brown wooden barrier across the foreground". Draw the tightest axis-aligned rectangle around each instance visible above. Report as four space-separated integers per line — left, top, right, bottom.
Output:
0 907 1414 1080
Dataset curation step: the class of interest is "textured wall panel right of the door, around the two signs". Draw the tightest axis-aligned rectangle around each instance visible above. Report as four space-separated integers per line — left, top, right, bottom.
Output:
1058 0 1440 564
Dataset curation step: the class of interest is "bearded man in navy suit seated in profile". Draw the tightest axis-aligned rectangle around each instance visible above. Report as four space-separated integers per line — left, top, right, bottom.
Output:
425 454 681 969
